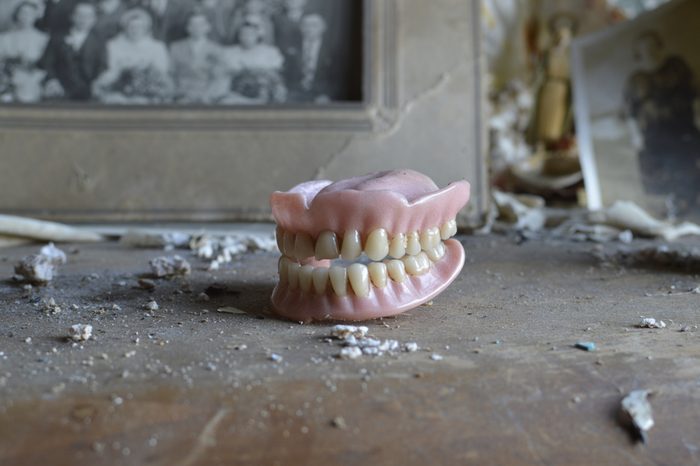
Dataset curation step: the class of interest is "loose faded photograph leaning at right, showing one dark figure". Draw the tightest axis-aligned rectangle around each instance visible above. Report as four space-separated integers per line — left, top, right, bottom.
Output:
573 0 700 219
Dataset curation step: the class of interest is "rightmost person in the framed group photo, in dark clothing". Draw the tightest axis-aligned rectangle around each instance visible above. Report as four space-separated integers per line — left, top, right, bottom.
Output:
285 13 335 103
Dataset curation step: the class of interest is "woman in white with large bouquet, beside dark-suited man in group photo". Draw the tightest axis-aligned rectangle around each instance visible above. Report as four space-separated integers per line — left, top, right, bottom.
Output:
93 8 173 104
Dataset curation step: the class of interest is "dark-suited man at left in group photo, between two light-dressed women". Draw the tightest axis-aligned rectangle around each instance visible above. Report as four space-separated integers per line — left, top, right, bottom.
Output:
41 1 105 101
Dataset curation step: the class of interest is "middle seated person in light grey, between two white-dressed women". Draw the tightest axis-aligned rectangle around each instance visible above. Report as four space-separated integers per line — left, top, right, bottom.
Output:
170 12 228 104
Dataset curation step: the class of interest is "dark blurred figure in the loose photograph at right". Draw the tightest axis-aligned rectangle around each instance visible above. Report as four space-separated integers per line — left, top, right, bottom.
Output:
624 31 700 210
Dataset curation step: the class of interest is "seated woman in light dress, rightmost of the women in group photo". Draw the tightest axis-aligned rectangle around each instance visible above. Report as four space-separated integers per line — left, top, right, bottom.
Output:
223 16 287 104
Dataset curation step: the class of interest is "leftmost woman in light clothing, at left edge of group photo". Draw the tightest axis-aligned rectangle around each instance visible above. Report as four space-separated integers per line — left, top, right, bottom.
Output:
0 1 49 102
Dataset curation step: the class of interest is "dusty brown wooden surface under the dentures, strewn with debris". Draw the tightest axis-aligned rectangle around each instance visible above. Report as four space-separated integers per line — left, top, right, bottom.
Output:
0 237 700 465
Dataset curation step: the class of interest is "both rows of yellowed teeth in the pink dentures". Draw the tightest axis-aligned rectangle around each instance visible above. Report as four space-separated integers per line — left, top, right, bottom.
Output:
277 219 457 297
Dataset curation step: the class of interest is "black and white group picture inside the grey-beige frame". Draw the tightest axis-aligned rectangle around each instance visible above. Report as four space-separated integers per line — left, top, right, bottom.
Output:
0 0 363 106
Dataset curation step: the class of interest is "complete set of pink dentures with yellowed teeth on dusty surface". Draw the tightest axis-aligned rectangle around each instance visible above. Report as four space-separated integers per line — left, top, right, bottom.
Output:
270 170 469 321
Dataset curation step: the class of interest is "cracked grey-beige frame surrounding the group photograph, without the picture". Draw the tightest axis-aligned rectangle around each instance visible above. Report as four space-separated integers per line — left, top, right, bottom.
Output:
0 0 488 223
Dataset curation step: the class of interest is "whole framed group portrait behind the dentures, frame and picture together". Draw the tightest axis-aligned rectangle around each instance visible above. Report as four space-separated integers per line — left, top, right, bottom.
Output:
0 0 487 226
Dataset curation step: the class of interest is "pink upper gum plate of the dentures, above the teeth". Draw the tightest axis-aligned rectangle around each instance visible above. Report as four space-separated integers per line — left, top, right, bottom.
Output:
270 170 469 237
